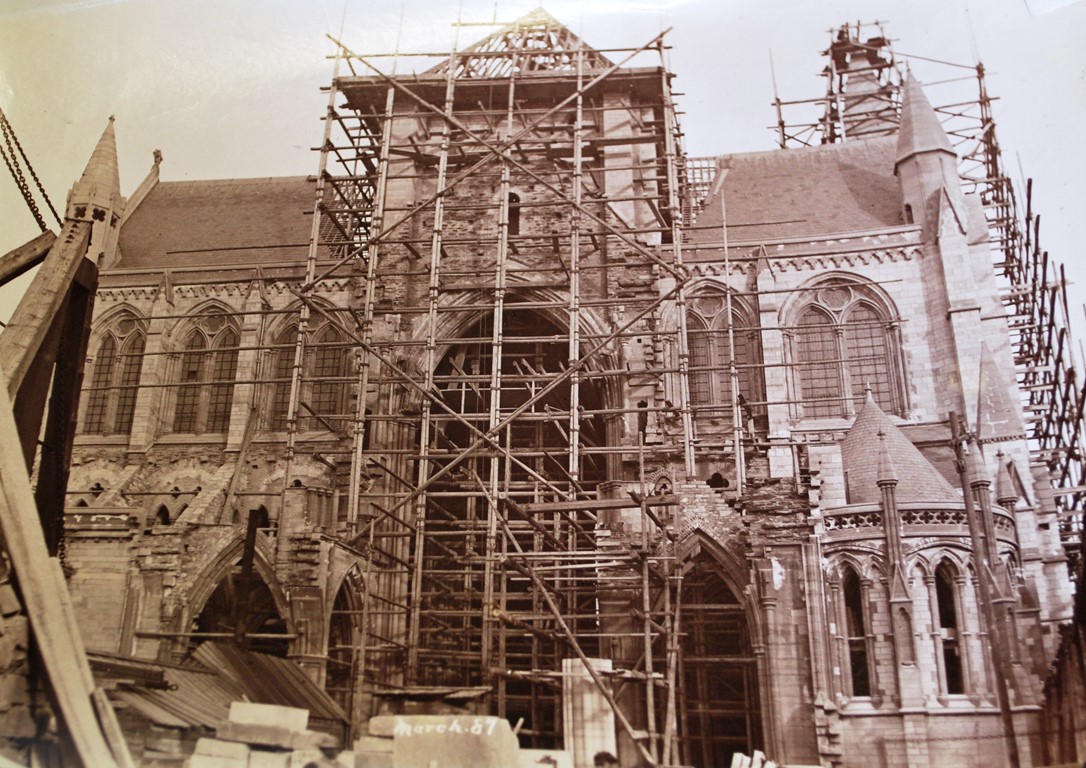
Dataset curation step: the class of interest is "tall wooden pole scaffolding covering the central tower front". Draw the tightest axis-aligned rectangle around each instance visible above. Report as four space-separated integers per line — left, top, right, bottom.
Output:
273 11 712 765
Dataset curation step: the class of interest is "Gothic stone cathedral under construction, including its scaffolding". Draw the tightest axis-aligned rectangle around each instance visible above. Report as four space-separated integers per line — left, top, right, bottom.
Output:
33 10 1081 768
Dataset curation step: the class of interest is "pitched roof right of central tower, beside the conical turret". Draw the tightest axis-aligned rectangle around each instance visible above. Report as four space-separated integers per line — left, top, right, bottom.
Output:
691 136 905 242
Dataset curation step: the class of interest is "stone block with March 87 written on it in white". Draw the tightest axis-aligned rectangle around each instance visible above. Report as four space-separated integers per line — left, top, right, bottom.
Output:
392 715 520 768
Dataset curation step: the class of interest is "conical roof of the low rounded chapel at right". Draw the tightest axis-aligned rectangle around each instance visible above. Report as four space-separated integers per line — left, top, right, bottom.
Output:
841 393 961 504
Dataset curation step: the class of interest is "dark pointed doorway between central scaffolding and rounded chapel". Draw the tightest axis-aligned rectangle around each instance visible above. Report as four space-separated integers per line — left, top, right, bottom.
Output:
679 553 763 768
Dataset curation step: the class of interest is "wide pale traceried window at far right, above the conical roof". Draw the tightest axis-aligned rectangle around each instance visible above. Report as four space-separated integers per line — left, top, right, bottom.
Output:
786 278 906 418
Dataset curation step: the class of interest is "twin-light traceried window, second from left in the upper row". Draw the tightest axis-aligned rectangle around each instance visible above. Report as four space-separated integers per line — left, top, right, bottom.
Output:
173 313 239 435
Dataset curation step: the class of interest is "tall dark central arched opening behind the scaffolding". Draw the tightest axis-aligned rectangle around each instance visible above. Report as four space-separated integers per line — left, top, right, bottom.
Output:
413 302 605 747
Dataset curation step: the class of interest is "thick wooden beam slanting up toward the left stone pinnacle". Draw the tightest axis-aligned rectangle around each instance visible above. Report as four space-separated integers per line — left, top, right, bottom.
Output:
0 219 90 397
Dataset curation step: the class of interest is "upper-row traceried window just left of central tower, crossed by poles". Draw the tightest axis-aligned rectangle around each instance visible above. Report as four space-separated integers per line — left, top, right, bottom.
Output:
265 325 351 430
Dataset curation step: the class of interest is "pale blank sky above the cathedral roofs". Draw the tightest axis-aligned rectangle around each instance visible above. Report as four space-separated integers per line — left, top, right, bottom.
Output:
0 0 1086 347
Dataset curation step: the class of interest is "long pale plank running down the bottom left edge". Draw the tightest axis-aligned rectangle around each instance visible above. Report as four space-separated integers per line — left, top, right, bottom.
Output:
0 369 117 768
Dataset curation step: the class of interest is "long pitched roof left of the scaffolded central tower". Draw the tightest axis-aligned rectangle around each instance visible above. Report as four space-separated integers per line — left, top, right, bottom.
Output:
115 176 315 268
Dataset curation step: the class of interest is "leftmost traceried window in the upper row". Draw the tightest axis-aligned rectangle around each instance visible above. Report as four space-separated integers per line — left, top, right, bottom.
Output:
83 314 147 435
